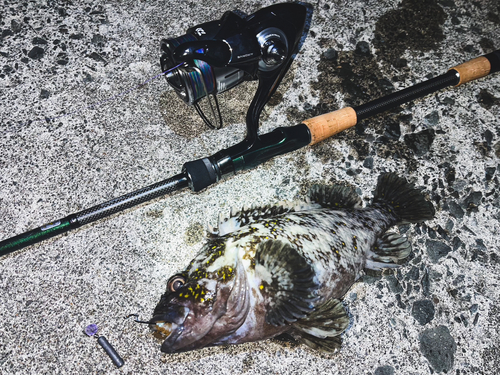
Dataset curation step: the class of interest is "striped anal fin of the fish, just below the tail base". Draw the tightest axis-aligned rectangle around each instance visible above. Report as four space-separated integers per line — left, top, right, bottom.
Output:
365 232 411 271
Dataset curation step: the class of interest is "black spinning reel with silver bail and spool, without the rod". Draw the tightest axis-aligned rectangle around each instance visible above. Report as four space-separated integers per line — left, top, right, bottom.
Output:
160 3 306 132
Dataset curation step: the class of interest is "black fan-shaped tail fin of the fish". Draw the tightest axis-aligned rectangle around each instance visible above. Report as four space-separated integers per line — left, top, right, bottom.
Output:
373 173 435 224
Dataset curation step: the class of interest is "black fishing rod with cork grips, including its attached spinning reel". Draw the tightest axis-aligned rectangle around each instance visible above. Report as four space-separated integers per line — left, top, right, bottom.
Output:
0 3 500 256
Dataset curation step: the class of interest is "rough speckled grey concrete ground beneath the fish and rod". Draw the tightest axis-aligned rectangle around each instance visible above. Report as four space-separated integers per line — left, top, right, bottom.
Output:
0 0 500 375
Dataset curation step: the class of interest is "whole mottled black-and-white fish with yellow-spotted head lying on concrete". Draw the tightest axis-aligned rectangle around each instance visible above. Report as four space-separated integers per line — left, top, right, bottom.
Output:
151 174 434 353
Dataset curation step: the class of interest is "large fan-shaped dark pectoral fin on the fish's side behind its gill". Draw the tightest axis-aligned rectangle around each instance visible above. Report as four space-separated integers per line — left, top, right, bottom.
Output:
255 240 319 326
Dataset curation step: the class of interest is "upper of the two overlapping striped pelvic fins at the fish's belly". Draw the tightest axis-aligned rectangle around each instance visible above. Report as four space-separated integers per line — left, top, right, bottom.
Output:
293 298 349 345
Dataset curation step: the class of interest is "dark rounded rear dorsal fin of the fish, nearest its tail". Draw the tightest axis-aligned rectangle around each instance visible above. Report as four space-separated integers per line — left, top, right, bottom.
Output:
309 185 362 209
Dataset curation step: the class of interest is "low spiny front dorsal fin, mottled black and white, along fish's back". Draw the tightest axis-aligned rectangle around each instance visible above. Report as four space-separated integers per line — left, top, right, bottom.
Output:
208 201 320 236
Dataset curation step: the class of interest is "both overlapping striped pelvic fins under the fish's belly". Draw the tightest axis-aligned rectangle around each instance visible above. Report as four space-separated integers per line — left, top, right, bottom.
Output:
293 298 349 351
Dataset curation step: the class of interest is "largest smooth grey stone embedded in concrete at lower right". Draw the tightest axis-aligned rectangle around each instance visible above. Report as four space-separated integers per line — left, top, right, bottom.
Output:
419 326 457 373
